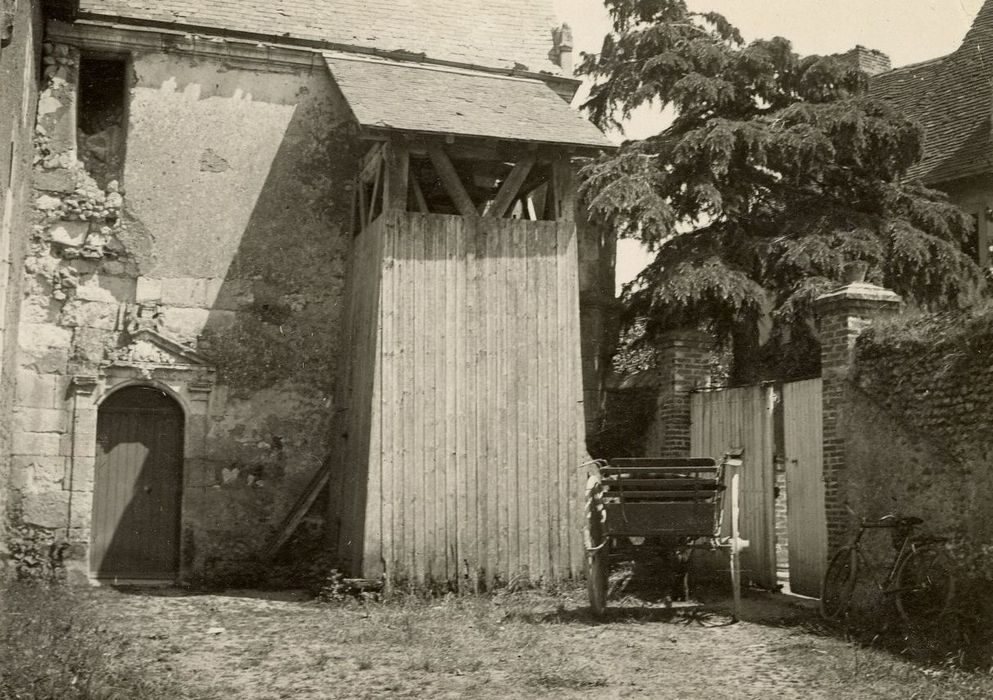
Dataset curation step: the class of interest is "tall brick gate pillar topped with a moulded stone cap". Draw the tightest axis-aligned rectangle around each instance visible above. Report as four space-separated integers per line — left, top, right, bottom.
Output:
815 282 902 552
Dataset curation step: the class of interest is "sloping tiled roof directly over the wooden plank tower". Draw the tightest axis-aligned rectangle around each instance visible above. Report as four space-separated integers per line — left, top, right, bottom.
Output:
325 53 613 148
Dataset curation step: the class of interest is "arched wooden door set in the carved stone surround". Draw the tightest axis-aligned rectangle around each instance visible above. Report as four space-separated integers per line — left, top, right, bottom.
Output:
90 386 183 580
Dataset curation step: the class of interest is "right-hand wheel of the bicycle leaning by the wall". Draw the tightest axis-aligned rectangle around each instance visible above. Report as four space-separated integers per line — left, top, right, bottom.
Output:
896 547 955 625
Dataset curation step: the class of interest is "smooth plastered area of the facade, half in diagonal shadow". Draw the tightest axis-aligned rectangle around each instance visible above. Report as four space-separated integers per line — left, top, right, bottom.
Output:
105 55 357 575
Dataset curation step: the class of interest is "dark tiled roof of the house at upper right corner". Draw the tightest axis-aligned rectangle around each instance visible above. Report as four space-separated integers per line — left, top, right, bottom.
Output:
869 0 993 184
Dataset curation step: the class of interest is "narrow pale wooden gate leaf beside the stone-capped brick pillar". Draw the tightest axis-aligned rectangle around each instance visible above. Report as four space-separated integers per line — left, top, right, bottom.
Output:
783 379 827 596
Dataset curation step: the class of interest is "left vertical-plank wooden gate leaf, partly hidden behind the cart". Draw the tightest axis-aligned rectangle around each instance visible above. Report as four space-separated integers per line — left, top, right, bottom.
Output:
690 386 776 588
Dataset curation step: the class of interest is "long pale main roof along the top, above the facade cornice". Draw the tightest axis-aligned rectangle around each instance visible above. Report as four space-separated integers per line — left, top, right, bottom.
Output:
79 0 560 73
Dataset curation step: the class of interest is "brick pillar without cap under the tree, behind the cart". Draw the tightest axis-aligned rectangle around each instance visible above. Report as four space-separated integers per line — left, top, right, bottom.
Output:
656 331 714 457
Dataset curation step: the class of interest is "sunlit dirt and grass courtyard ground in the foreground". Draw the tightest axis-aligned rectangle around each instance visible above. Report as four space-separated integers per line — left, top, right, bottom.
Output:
77 589 993 700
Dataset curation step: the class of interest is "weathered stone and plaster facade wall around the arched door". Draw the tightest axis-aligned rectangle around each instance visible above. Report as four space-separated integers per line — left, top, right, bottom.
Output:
12 25 356 578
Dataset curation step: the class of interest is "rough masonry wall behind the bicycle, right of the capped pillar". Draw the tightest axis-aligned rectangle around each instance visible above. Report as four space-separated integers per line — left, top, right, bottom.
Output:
843 308 993 544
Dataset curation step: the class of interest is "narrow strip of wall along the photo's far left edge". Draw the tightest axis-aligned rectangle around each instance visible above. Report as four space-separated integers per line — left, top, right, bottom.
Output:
0 0 41 575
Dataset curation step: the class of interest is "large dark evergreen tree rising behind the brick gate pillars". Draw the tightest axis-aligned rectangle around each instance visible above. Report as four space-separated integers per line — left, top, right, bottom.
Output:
579 0 983 381
